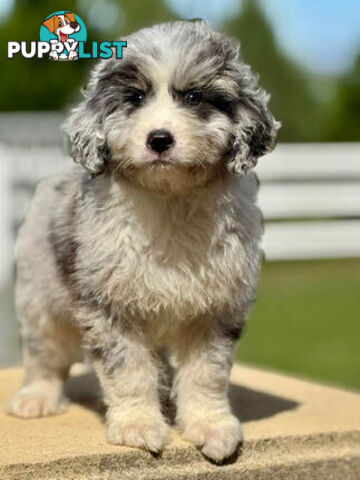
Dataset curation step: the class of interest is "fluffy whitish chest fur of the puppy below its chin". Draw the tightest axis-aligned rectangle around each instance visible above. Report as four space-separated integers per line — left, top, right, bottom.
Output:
80 202 245 318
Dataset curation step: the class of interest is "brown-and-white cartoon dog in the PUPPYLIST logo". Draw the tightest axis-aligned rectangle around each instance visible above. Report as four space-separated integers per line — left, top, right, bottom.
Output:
42 12 80 60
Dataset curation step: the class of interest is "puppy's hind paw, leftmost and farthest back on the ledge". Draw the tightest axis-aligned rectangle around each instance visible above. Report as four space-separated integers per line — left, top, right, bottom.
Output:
6 385 68 418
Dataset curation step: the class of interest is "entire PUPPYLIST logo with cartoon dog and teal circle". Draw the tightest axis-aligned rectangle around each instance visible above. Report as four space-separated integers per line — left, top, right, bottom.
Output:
8 10 127 61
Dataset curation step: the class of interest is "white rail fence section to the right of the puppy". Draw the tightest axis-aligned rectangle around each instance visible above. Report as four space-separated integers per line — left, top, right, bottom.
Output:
257 143 360 260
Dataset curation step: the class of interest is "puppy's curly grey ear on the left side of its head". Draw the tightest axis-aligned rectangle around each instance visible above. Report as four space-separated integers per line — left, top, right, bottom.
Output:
63 99 109 175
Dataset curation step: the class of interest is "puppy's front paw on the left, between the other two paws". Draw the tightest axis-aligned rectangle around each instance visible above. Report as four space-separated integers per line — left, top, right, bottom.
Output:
107 415 169 452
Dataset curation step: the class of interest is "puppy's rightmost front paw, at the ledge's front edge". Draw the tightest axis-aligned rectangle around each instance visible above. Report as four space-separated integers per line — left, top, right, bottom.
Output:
183 414 243 463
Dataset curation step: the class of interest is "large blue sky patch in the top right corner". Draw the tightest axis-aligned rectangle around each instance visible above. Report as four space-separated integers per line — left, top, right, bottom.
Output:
261 0 360 73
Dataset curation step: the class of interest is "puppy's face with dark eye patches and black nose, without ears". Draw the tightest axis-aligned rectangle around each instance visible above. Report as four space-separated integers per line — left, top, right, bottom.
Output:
103 49 239 192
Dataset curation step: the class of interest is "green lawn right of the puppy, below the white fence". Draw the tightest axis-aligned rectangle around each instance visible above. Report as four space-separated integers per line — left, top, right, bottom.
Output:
236 259 360 389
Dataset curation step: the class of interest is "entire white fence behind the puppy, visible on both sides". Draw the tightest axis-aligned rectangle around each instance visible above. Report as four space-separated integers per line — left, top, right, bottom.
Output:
0 113 360 283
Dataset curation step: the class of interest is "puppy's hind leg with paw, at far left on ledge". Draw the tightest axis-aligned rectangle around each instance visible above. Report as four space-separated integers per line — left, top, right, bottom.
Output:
7 314 79 418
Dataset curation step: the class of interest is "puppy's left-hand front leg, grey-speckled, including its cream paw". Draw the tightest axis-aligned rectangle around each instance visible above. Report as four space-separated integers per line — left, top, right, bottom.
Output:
85 313 169 452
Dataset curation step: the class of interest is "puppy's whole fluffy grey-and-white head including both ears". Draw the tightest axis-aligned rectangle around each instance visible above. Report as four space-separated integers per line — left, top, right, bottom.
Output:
66 22 279 193
